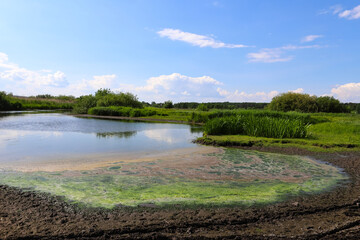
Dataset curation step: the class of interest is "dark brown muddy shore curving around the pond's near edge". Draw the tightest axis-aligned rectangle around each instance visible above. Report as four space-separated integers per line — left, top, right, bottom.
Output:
0 147 360 239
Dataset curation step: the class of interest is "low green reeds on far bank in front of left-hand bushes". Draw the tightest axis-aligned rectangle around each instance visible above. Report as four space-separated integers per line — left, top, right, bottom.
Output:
88 106 157 117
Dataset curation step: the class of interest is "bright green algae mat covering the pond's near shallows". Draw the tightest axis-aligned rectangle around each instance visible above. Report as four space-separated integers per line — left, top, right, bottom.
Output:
0 149 347 208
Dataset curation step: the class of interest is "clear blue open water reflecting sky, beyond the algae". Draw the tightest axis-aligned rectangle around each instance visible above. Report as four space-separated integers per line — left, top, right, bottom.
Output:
0 113 201 168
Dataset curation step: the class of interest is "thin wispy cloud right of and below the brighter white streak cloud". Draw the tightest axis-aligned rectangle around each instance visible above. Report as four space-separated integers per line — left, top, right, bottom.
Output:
247 45 321 63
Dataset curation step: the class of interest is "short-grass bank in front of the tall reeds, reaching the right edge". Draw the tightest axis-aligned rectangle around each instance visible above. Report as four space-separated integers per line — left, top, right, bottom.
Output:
197 113 360 152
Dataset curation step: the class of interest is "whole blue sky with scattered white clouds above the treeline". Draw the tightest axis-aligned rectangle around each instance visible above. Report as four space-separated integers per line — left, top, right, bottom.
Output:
0 0 360 102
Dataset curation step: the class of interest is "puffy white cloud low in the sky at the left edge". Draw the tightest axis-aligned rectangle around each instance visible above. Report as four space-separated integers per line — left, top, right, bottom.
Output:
0 53 69 87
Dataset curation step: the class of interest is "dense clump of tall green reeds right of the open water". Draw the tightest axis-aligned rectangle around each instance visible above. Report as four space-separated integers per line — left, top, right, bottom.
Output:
204 114 309 138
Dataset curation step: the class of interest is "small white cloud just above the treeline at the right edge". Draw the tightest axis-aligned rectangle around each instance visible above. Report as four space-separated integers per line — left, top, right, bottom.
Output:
331 82 360 103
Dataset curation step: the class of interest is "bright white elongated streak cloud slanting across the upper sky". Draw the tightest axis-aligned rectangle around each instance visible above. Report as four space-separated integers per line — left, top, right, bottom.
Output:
157 28 248 48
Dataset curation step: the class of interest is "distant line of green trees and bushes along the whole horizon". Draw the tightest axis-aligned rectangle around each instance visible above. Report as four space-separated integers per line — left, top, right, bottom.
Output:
0 89 360 113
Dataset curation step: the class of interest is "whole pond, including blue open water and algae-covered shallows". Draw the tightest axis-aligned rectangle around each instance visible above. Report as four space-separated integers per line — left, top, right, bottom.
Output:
0 112 347 208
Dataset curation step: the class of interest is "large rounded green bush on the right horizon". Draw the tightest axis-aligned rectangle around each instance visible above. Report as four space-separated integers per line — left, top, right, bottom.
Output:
268 92 318 113
